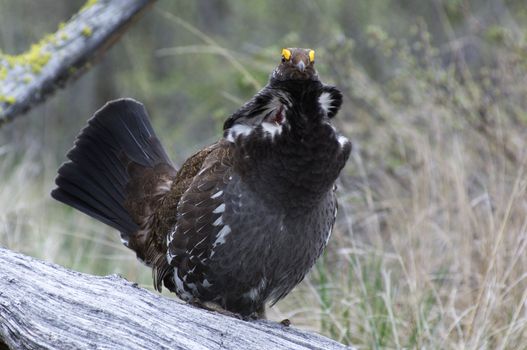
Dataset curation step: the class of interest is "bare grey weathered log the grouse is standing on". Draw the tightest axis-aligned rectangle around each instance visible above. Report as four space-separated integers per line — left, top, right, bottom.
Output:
0 248 354 350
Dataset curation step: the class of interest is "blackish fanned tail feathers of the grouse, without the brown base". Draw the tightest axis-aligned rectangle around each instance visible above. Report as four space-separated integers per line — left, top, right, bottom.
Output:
51 99 172 238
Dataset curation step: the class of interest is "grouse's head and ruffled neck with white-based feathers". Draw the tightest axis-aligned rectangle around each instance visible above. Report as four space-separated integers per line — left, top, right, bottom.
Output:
223 48 342 137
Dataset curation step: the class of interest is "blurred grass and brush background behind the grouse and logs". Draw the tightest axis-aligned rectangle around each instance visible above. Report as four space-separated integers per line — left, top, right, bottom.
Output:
0 0 527 349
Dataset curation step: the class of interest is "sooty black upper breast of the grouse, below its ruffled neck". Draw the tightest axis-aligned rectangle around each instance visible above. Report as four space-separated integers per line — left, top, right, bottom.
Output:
233 122 351 210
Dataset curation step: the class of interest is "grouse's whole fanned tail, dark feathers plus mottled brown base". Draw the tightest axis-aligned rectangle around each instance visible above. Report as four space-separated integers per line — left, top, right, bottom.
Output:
51 99 176 265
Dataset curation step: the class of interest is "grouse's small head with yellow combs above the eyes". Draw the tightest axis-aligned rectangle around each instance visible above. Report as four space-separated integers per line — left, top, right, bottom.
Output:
271 48 318 81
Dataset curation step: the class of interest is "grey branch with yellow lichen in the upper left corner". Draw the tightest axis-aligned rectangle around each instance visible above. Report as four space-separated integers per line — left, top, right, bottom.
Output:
0 0 155 125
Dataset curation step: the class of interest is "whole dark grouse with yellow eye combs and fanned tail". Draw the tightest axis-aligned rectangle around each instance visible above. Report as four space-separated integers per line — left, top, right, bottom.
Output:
51 48 351 317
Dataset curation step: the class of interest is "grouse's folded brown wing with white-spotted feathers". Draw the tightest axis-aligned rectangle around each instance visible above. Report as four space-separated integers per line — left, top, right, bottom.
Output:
157 141 232 297
